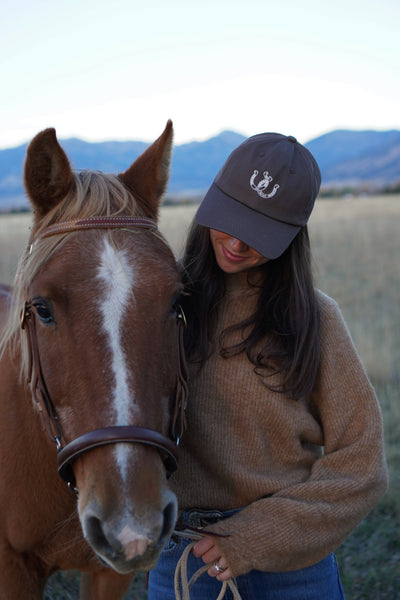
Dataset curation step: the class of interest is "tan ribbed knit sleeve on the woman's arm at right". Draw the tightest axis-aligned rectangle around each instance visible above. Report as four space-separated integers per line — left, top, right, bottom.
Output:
209 296 387 576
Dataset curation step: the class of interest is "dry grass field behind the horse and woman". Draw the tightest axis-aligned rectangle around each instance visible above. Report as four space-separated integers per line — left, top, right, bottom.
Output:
0 196 400 600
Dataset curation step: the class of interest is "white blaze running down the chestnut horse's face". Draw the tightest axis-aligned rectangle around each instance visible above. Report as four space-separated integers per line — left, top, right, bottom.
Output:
98 238 137 480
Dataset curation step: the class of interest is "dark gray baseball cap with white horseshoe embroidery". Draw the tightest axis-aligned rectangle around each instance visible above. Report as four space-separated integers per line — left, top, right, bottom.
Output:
195 133 321 259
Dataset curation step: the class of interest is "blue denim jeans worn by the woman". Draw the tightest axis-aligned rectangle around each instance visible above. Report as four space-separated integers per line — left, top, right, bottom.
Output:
148 510 344 600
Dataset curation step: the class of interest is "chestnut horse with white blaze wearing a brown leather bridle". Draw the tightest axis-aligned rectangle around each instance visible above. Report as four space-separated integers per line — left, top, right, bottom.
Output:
0 121 187 600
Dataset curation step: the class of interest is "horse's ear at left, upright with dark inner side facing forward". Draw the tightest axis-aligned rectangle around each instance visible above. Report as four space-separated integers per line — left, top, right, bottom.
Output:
24 128 73 218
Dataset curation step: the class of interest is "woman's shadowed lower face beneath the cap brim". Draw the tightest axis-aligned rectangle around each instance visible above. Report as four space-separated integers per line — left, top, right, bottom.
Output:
210 229 268 273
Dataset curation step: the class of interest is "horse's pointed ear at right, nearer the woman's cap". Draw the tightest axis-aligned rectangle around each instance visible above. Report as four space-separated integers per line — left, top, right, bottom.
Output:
118 120 173 219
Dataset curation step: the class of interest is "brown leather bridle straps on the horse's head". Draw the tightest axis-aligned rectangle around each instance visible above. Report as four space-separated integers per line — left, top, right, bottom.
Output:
21 217 188 493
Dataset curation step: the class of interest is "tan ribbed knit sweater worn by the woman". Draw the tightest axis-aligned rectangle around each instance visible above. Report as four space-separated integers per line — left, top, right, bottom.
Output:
170 279 387 576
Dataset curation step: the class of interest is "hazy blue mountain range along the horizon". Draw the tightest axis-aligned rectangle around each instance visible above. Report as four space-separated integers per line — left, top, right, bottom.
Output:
0 130 400 211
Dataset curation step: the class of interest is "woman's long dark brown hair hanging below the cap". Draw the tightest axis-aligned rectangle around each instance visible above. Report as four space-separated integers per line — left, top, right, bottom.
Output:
181 223 320 399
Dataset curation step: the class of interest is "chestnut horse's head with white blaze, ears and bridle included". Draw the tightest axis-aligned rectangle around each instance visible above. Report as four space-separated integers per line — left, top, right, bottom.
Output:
16 122 188 572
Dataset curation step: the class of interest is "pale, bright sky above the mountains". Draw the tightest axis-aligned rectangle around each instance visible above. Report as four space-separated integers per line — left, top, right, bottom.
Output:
0 0 400 149
